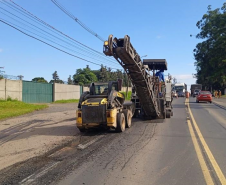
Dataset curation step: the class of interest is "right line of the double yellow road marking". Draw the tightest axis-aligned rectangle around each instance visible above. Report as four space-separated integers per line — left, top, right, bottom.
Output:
186 99 226 185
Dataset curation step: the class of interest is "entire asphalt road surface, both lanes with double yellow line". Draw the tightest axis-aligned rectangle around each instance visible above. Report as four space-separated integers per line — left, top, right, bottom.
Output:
0 98 226 185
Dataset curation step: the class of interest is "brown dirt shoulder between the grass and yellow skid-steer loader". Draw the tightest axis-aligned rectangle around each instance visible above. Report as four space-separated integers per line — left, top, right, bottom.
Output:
0 103 80 170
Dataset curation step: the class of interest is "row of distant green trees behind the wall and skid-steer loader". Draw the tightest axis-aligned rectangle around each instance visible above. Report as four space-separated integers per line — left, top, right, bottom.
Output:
32 65 131 86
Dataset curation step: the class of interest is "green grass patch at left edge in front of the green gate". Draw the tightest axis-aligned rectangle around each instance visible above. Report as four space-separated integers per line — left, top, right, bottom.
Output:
0 98 48 120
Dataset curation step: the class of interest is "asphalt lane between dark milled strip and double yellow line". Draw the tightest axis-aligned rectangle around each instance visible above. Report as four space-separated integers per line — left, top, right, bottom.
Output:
56 98 205 185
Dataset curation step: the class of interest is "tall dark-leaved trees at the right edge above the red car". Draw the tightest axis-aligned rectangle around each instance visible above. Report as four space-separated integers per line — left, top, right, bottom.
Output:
193 3 226 91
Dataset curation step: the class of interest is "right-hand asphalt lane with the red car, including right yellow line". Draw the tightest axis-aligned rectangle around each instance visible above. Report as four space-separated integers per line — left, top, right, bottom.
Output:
190 98 226 184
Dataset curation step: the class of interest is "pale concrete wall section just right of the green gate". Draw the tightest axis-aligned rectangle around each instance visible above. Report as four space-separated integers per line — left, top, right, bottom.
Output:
53 83 80 101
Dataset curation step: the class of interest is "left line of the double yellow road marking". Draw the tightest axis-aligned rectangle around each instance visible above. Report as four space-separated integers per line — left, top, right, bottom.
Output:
188 120 214 185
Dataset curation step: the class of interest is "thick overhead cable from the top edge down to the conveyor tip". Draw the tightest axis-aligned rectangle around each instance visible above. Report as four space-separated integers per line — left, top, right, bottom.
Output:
51 0 105 42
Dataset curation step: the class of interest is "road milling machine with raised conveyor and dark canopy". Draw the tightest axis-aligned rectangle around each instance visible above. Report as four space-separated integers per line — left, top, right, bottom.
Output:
103 35 173 119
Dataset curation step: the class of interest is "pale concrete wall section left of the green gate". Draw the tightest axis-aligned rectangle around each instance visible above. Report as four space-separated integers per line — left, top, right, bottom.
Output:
0 79 22 101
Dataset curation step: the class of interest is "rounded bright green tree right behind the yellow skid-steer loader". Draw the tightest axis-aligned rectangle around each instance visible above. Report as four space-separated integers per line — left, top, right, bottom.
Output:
73 67 97 85
